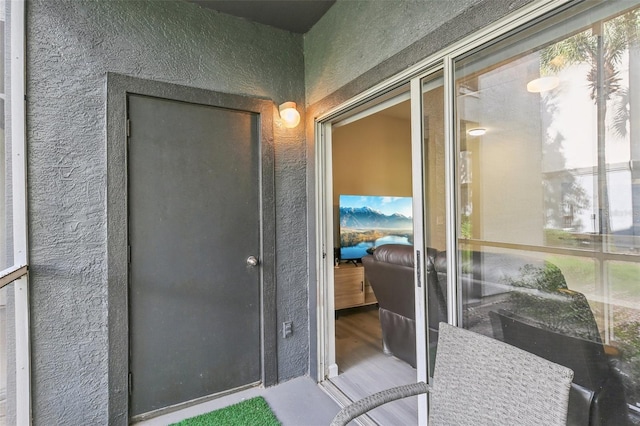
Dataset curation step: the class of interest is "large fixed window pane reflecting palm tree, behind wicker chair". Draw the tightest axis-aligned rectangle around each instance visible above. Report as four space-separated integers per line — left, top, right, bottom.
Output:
455 2 640 424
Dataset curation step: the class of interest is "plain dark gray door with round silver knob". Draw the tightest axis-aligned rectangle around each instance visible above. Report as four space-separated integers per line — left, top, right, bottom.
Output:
128 95 262 416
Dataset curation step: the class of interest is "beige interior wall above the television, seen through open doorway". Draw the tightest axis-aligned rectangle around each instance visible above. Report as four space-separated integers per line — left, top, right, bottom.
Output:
332 113 412 245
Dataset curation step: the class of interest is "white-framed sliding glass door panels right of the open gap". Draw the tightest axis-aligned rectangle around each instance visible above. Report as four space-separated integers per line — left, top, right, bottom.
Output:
320 0 640 425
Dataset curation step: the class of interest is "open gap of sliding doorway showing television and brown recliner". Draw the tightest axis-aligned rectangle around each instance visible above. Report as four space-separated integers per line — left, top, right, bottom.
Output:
327 84 418 424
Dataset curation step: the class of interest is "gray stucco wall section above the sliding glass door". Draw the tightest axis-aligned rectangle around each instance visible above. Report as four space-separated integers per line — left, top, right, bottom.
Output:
304 0 481 104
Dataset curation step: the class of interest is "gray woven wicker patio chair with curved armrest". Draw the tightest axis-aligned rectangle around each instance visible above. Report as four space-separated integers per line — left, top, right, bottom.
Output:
331 323 573 426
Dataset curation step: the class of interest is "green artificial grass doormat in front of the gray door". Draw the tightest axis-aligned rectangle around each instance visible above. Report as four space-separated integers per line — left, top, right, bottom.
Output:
171 396 280 426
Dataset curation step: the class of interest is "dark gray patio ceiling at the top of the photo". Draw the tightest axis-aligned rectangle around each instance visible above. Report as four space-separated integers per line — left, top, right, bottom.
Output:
187 0 336 34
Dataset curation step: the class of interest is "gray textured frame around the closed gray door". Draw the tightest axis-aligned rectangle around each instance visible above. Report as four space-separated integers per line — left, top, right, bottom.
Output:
105 73 278 424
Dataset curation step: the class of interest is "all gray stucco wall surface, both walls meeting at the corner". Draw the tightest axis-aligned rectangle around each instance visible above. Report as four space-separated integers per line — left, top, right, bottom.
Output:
27 0 544 425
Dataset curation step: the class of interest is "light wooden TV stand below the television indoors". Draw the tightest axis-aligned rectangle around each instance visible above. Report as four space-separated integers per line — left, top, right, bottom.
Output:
333 263 378 310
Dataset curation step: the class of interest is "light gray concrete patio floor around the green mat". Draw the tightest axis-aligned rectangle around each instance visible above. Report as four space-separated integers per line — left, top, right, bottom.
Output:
135 377 340 426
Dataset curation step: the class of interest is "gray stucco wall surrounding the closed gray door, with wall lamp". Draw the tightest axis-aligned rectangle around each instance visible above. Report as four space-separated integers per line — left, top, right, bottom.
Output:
27 0 309 425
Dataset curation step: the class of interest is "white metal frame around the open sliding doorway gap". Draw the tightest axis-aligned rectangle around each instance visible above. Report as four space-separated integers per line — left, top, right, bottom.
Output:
314 84 428 416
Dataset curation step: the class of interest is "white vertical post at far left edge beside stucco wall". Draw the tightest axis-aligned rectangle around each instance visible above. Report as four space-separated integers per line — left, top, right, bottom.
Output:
10 0 31 425
